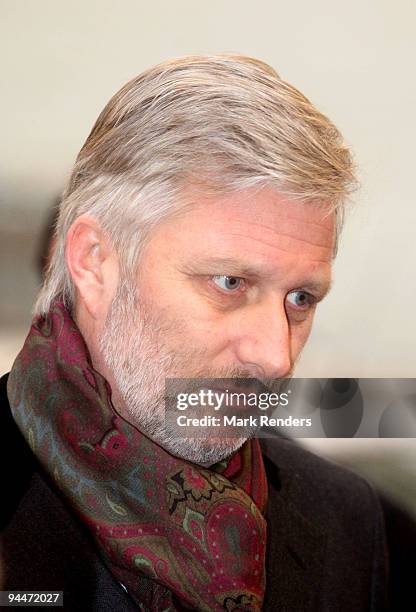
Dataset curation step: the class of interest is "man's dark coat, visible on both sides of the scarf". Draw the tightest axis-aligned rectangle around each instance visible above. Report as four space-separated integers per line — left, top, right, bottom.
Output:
0 377 396 612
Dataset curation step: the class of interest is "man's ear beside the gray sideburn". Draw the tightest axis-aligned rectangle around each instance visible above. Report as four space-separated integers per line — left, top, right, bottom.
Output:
65 215 119 319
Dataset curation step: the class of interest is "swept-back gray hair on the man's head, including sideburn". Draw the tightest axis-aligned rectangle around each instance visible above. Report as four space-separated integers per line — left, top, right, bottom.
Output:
34 55 355 314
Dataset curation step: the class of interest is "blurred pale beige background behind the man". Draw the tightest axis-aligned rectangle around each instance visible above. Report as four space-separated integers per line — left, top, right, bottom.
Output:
0 0 416 515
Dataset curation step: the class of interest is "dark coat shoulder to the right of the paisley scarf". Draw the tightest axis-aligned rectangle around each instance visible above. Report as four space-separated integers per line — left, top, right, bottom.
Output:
261 437 388 612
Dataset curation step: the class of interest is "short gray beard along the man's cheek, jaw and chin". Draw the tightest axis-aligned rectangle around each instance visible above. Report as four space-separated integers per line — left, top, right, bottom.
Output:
99 292 252 466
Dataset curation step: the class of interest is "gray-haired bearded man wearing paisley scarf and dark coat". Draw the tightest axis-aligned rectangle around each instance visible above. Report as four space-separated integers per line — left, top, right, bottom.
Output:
2 56 387 612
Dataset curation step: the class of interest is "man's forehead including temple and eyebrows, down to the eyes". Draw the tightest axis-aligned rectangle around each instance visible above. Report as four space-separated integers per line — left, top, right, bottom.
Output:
139 189 334 296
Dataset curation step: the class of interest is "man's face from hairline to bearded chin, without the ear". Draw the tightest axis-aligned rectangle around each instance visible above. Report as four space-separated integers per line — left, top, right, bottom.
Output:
100 188 334 464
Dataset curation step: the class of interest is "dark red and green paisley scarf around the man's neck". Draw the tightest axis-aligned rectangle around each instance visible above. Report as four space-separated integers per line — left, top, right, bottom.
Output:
8 302 267 612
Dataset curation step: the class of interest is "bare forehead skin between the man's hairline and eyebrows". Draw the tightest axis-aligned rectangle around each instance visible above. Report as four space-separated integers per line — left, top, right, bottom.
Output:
156 188 335 261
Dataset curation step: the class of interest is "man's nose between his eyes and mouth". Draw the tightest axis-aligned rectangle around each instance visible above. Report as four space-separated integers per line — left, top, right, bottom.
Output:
234 299 292 379
